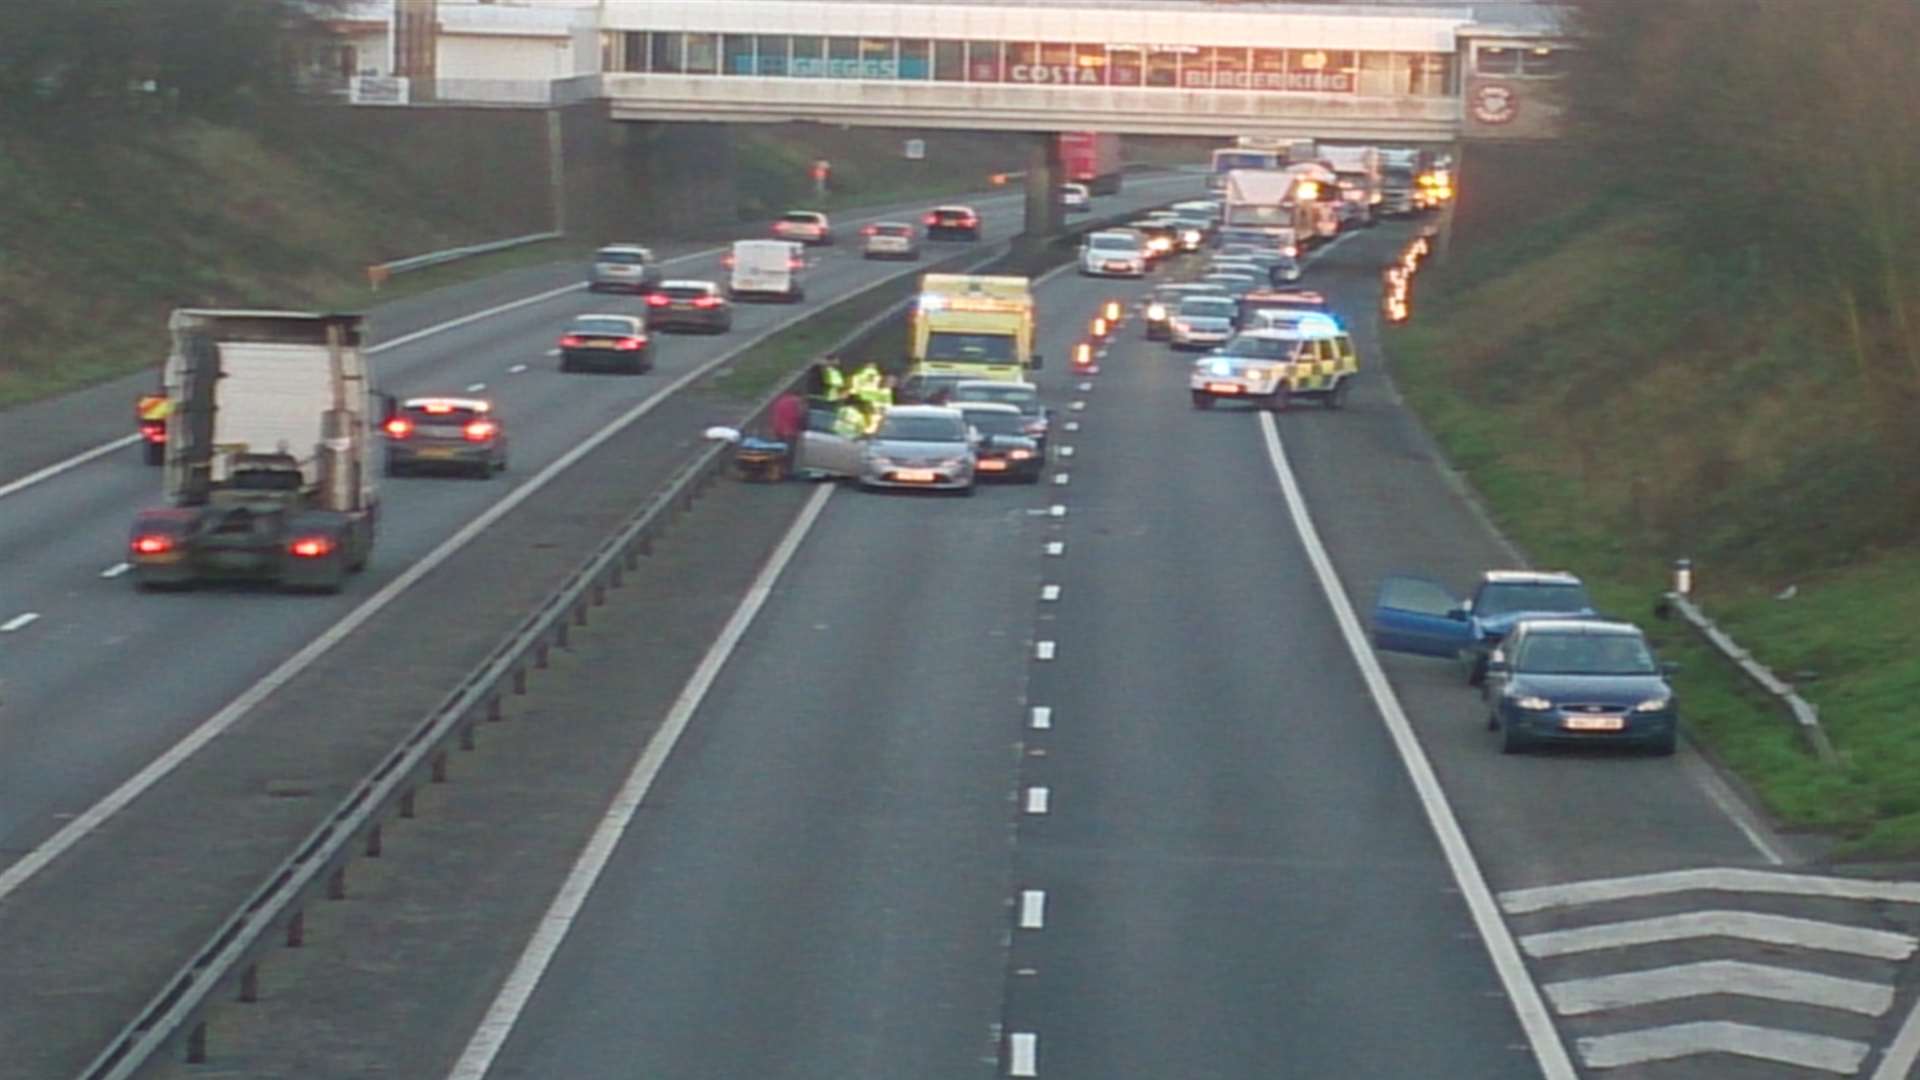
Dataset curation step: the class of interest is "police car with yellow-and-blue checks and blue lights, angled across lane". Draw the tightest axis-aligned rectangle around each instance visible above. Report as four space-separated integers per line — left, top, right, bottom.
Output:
1187 317 1359 409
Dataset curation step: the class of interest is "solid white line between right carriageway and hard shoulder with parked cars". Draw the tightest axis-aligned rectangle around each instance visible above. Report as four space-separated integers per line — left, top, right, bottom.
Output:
1260 411 1578 1080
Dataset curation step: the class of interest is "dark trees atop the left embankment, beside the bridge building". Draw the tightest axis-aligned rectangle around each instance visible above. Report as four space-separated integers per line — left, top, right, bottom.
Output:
0 0 349 119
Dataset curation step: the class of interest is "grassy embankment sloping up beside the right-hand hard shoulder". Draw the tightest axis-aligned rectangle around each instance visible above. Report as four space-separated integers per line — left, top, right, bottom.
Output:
1388 204 1920 859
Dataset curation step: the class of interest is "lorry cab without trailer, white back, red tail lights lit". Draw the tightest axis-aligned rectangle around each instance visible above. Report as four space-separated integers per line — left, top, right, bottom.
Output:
127 307 392 592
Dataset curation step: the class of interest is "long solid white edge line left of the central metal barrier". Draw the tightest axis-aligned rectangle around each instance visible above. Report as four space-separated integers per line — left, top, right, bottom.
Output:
0 279 871 901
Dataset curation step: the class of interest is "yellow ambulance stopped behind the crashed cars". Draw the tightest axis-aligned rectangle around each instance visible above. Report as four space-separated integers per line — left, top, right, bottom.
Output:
908 273 1041 382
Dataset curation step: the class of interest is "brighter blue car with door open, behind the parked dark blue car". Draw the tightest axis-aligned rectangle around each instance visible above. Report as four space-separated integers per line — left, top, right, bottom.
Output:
1373 571 1597 686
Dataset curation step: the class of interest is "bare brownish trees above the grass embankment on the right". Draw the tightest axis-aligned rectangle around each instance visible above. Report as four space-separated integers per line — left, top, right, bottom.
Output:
1567 0 1920 384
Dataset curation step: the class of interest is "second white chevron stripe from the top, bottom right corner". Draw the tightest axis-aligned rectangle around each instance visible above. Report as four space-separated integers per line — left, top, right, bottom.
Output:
1521 911 1920 961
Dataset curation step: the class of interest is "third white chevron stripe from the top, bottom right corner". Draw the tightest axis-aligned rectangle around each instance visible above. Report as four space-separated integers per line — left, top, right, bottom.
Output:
1542 961 1893 1017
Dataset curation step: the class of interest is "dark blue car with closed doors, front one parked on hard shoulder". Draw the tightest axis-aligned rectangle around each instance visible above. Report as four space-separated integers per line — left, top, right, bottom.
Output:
1486 619 1680 755
